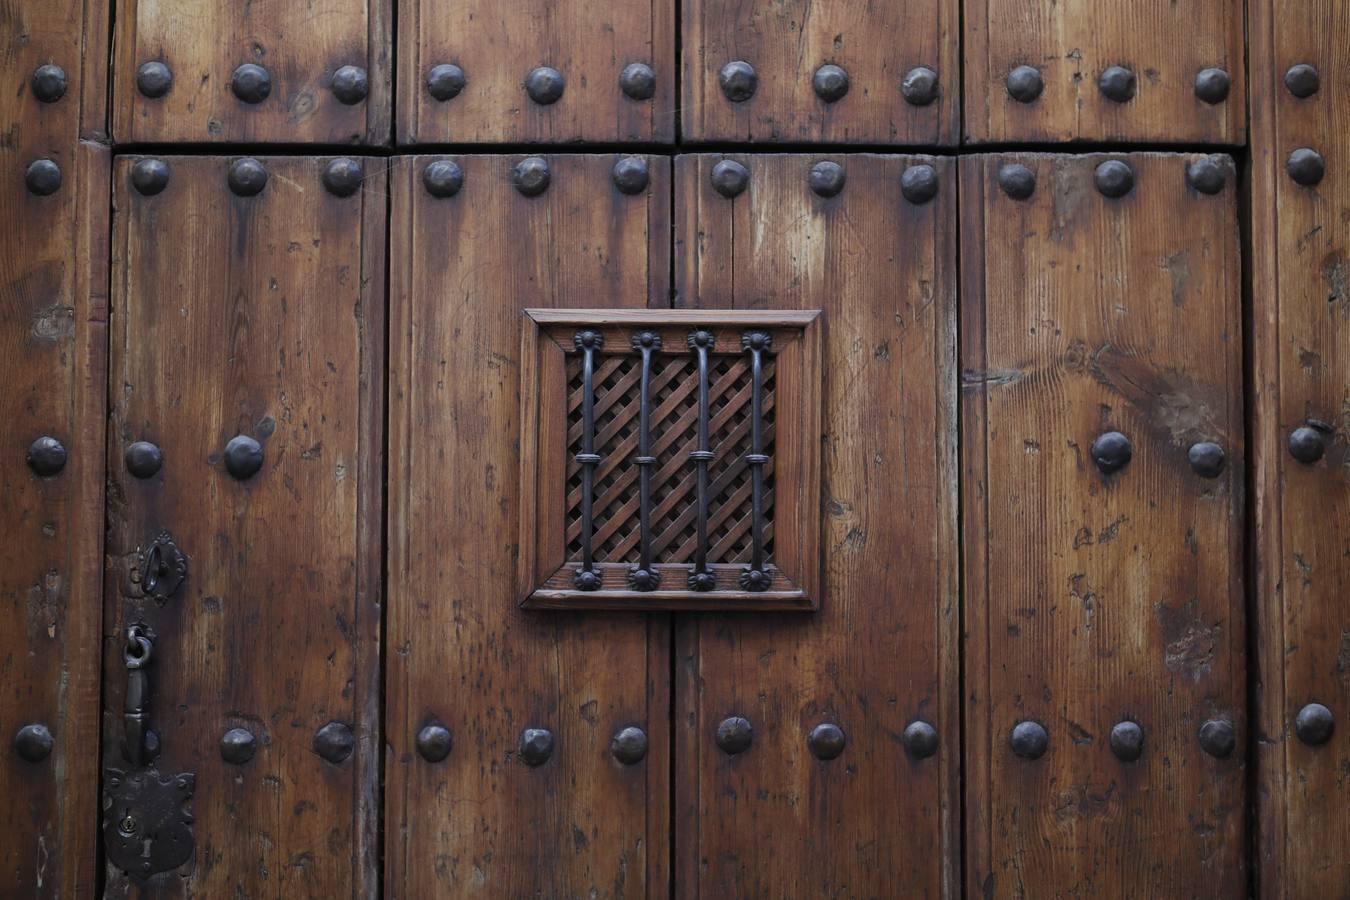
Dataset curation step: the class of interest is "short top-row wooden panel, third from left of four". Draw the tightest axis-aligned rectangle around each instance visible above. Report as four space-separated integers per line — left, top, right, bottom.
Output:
680 0 961 144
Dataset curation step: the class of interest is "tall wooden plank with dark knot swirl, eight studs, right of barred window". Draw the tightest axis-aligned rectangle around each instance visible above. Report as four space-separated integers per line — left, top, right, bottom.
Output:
961 154 1246 897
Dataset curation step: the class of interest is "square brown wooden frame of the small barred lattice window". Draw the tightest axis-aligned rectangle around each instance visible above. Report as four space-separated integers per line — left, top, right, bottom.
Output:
517 309 824 611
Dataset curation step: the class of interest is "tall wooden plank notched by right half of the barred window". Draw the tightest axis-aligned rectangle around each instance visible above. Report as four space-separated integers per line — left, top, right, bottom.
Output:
675 154 960 897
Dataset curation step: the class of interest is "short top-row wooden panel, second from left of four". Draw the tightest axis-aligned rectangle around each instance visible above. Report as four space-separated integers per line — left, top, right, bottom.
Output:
398 0 676 144
